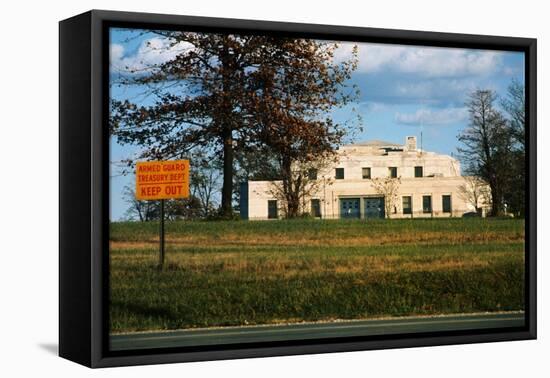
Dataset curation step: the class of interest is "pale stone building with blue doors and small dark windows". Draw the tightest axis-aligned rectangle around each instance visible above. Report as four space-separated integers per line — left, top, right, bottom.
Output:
240 137 490 220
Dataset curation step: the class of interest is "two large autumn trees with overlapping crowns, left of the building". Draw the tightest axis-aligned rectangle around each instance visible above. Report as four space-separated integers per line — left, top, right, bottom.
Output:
110 31 359 218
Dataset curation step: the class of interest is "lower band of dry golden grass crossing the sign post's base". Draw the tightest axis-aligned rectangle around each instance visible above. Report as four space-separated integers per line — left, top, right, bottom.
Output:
111 243 523 278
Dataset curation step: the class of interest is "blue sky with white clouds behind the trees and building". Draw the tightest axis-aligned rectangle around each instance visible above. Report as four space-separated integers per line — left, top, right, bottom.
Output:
110 29 525 220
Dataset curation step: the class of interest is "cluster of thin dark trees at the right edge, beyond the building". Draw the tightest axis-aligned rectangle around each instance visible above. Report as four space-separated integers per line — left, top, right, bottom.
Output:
458 80 527 216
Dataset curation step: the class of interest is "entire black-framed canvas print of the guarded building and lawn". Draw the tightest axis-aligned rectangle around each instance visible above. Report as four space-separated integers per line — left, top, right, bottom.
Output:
59 11 536 367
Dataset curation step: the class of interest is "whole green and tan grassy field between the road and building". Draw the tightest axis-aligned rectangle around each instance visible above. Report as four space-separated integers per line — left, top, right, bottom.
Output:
110 218 524 333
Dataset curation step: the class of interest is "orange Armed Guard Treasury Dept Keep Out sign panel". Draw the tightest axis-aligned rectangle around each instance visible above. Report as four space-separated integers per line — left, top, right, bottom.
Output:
136 160 189 200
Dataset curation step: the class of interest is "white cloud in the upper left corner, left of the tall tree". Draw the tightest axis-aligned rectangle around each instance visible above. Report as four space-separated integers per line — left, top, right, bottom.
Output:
110 37 193 74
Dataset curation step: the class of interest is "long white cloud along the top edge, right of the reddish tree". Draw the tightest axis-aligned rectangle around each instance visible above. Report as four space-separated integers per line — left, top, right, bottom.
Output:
335 42 502 77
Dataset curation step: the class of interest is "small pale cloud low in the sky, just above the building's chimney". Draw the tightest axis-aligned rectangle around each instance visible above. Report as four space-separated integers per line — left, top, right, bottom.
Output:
395 107 468 126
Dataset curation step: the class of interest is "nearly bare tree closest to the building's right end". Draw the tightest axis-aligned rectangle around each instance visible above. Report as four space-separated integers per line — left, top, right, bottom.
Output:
458 90 513 216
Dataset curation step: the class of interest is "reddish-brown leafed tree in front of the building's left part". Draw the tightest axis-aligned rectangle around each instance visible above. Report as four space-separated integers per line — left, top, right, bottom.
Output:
246 38 358 218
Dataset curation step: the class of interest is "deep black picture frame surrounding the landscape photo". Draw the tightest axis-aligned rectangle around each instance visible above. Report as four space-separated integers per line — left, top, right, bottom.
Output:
59 10 537 368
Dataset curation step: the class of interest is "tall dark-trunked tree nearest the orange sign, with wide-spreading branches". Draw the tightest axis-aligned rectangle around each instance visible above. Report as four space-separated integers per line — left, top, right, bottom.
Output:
110 31 276 216
